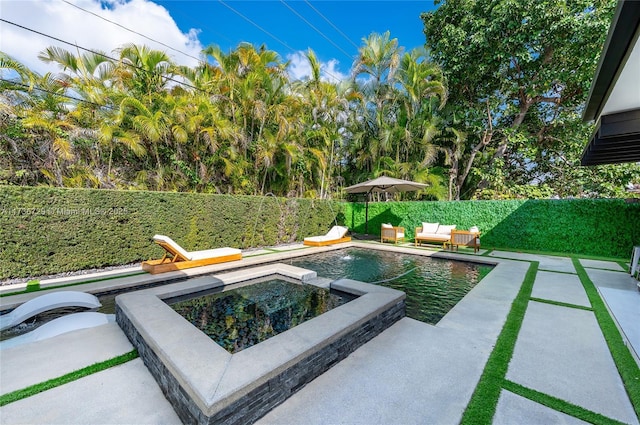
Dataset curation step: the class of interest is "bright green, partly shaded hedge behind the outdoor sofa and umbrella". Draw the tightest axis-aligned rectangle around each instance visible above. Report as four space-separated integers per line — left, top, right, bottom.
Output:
344 199 640 259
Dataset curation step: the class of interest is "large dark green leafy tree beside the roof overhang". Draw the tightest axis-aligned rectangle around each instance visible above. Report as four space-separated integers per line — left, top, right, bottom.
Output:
422 0 638 197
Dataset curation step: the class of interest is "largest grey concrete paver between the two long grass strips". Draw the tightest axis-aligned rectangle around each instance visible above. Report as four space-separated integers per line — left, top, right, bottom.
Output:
507 301 638 424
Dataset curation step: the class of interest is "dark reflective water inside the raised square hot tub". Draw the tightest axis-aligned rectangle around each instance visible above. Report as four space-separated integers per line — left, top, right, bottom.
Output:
166 278 354 354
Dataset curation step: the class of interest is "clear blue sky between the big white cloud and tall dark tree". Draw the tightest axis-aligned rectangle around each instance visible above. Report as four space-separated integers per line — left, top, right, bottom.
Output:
157 0 434 72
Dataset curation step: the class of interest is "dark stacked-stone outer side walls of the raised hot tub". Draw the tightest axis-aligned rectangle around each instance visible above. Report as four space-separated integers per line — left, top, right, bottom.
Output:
116 299 405 425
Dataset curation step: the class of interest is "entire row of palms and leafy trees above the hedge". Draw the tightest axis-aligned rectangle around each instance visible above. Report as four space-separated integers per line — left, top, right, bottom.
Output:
0 0 640 199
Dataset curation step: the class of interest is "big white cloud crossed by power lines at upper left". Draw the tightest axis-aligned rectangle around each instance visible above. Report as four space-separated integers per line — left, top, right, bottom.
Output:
0 0 202 73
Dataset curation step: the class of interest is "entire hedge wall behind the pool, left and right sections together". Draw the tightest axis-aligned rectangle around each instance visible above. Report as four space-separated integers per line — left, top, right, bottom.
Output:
0 186 640 279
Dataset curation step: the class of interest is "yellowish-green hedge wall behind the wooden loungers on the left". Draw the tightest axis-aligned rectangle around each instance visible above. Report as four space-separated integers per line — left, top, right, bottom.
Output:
0 186 344 280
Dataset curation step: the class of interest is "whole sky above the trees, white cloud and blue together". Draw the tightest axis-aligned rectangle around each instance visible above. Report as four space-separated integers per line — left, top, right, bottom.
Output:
0 0 436 78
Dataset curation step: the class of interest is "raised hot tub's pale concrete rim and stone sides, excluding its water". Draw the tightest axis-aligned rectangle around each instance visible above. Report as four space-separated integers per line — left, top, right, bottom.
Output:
116 264 405 424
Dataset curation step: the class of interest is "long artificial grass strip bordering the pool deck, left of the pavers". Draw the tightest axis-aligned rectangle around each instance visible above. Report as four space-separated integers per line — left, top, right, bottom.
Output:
460 261 540 425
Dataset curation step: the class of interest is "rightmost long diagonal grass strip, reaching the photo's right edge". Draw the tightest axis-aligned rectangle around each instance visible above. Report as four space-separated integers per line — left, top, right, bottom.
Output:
572 258 640 418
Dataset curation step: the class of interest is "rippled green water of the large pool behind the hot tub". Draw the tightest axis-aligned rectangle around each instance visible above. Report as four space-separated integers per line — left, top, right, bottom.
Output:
290 248 493 324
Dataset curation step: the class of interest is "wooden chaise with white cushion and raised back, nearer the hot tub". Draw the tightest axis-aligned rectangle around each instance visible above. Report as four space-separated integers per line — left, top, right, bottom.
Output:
142 235 242 274
